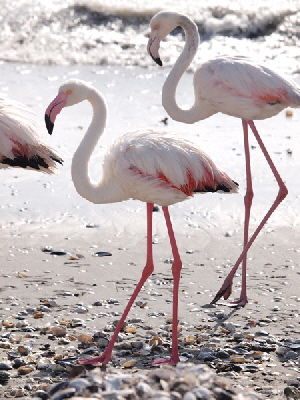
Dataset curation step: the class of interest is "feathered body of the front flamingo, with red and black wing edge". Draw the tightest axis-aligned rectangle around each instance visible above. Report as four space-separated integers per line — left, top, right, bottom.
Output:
104 130 237 205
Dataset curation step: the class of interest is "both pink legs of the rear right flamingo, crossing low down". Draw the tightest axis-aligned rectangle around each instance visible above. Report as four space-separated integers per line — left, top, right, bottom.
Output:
211 120 288 307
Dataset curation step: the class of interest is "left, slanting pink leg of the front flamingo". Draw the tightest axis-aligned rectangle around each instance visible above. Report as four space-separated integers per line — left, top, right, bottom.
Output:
79 203 154 366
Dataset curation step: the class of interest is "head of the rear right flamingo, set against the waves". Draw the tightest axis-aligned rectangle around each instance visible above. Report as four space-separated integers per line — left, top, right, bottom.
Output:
147 11 184 66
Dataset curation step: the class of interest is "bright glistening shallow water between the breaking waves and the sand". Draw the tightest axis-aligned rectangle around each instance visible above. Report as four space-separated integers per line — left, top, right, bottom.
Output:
0 63 300 234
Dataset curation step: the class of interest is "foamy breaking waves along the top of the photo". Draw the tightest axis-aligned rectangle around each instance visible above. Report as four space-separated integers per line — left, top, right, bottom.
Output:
0 0 300 74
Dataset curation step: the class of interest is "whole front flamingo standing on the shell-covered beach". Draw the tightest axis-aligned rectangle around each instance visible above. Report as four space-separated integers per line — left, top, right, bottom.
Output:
45 79 238 365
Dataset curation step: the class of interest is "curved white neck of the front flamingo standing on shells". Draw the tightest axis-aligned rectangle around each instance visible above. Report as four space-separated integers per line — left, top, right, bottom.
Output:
71 89 128 204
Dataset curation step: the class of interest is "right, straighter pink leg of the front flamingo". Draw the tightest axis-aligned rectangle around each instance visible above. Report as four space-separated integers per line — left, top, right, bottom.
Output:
152 206 182 365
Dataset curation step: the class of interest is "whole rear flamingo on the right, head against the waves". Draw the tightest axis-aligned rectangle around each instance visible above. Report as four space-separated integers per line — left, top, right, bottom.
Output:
147 11 300 307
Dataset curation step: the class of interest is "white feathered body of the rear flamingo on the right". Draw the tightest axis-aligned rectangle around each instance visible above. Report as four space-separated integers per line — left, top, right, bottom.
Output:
194 56 300 120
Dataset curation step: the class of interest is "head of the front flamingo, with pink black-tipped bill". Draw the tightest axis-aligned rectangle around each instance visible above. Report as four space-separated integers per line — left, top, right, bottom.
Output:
45 79 91 135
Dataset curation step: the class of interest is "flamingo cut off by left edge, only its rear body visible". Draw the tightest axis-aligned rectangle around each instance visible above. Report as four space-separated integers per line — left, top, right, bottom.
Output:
0 98 62 174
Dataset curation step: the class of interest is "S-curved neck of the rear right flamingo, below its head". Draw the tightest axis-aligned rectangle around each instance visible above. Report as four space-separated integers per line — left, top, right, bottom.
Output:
162 16 215 124
